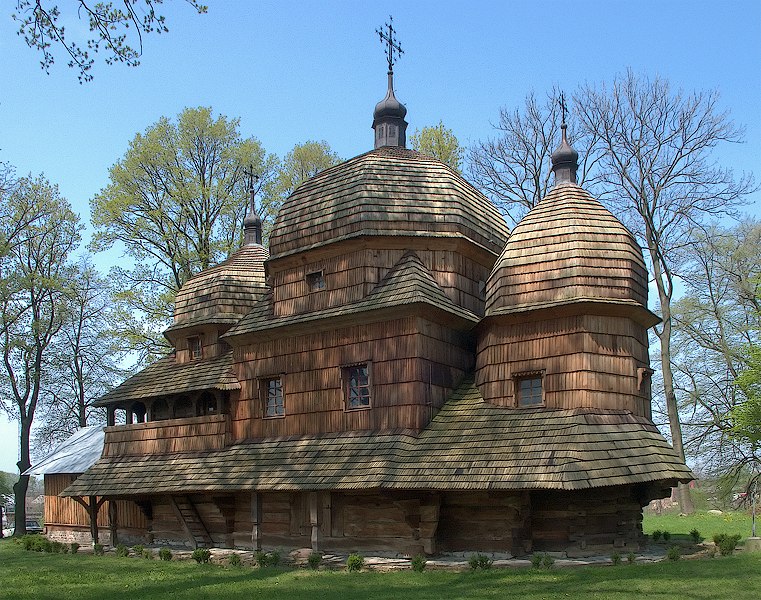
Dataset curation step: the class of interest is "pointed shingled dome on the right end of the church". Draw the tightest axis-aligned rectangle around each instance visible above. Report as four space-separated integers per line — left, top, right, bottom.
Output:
486 184 648 316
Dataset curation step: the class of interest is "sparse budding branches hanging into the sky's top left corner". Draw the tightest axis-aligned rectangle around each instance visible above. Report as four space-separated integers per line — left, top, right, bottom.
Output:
12 0 207 83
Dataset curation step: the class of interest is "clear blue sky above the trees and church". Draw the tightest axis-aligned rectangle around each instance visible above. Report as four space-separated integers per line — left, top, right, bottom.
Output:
0 0 761 471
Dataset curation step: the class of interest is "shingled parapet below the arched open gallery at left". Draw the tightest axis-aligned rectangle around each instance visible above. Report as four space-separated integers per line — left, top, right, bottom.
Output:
103 415 229 456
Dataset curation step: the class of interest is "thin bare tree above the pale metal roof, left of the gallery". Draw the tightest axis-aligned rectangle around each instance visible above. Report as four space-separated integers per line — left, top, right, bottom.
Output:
34 257 127 451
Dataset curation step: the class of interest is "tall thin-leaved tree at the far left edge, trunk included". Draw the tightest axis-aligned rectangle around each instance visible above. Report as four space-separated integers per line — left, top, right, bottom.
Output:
0 177 79 535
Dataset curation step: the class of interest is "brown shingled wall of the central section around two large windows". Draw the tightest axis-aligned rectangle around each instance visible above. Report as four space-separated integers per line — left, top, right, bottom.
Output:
231 317 473 440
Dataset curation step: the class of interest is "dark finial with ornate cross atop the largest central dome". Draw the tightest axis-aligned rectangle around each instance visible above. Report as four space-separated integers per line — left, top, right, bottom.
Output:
373 17 407 148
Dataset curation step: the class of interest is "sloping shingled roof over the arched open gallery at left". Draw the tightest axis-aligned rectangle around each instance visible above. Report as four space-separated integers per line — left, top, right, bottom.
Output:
96 351 240 406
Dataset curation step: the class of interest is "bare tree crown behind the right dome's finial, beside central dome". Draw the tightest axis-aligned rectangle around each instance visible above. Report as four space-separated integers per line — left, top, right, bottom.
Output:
468 90 598 224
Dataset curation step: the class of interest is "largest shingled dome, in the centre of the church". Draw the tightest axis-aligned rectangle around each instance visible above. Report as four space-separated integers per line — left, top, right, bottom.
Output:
270 146 508 258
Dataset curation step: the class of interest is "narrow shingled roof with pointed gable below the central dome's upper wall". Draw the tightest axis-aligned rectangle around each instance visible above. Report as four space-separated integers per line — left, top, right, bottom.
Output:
225 251 479 337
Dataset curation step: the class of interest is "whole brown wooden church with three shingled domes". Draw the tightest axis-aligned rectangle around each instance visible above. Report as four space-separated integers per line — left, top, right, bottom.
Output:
48 34 692 555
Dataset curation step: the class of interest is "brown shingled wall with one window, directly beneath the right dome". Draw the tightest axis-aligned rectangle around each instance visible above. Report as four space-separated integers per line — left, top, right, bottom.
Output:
476 315 650 418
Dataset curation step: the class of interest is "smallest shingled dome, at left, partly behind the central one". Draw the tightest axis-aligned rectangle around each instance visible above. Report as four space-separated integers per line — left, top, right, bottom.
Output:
165 244 269 340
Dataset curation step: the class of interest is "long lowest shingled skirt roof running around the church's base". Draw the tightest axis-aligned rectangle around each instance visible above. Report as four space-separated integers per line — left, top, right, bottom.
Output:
68 381 692 496
